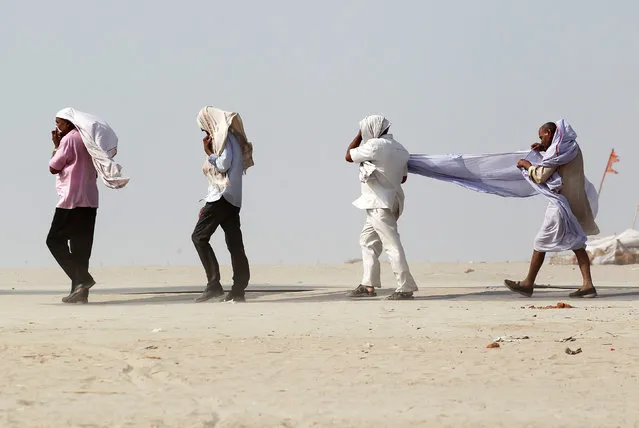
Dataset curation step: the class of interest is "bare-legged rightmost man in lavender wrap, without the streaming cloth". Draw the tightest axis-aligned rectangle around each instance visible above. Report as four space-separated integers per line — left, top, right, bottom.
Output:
504 120 599 297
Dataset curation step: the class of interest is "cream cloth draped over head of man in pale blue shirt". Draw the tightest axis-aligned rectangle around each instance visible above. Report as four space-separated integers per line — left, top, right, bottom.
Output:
197 106 255 188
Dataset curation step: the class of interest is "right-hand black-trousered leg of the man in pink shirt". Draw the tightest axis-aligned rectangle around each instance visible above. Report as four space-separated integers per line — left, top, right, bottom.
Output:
69 208 97 288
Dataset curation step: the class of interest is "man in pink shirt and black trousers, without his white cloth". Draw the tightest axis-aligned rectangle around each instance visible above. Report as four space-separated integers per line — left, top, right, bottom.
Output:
47 113 98 303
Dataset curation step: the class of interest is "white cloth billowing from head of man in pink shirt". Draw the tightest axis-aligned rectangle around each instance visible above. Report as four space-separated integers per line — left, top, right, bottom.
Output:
55 107 129 189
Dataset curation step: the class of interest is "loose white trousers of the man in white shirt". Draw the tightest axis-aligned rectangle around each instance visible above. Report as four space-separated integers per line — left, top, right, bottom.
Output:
359 208 417 293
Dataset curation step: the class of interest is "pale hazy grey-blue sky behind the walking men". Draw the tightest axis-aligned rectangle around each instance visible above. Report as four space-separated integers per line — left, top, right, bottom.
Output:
0 0 639 267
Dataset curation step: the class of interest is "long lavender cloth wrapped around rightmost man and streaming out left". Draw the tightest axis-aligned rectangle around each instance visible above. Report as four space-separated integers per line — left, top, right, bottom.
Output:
408 120 598 252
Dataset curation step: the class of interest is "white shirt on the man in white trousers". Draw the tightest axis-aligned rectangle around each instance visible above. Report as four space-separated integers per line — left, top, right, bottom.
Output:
350 134 409 214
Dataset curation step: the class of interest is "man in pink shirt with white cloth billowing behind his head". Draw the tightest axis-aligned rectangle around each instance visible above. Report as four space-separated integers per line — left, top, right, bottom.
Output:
47 108 129 303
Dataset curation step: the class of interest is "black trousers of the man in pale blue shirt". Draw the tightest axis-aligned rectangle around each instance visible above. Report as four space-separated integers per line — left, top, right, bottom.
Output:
191 197 251 295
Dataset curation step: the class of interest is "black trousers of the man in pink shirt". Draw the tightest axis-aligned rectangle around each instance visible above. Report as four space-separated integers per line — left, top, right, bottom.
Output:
47 207 97 291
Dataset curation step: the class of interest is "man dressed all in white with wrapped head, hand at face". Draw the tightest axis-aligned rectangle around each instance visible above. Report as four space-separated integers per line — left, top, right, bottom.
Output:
346 115 417 300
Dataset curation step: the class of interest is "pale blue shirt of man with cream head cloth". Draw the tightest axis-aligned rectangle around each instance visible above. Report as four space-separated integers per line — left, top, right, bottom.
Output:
205 132 244 208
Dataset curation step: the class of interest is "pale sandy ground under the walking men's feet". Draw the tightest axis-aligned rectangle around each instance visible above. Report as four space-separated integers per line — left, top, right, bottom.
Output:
0 264 639 427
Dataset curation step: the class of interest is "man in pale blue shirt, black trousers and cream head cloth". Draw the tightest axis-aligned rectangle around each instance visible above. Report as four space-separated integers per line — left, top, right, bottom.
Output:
191 107 253 303
